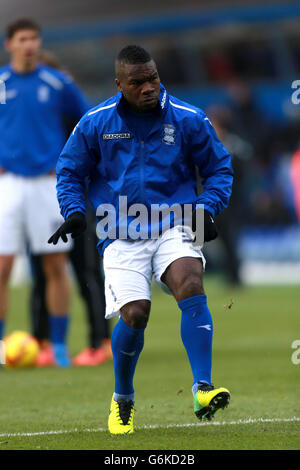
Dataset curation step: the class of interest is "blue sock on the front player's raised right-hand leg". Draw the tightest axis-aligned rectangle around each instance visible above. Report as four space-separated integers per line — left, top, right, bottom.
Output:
178 295 213 391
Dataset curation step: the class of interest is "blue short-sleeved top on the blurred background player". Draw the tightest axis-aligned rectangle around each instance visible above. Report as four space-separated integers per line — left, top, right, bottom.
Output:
0 60 91 177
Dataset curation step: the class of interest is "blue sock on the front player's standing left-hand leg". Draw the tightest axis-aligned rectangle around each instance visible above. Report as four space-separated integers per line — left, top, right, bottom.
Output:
111 317 145 400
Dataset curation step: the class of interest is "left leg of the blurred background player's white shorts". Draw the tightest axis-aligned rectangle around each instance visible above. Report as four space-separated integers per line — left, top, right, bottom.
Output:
0 173 26 255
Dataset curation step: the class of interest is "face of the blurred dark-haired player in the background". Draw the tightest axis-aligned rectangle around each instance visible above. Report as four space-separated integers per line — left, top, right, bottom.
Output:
6 29 41 64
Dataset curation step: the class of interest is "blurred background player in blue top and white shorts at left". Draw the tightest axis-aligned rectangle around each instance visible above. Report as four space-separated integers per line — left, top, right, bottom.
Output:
0 18 89 367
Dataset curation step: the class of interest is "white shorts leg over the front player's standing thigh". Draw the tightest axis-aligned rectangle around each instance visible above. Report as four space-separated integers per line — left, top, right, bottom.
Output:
103 240 153 318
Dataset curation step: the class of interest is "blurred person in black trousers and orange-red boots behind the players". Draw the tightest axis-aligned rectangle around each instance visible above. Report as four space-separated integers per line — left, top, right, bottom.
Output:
30 49 112 366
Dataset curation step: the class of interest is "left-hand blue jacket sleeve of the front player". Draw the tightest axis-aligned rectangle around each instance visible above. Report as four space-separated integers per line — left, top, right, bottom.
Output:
56 116 99 220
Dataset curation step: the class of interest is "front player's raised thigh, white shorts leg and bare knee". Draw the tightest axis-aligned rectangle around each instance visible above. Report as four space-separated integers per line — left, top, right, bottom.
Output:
153 227 205 299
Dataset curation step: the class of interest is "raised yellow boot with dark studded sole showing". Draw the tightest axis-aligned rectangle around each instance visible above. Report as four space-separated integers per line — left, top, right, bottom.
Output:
194 383 230 421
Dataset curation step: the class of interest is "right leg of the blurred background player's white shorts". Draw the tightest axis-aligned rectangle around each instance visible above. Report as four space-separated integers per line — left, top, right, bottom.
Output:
25 175 72 254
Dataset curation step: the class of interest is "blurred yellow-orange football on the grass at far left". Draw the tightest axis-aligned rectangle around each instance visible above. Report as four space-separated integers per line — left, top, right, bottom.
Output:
3 331 39 368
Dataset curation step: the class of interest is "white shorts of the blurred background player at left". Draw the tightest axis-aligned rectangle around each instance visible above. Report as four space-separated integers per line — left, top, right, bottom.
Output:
0 173 72 255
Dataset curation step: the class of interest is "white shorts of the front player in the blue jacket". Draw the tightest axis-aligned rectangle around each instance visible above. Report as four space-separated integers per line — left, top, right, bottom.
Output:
103 226 205 318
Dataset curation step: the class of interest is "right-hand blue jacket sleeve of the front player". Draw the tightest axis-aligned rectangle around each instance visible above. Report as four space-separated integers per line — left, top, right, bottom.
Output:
191 112 233 216
